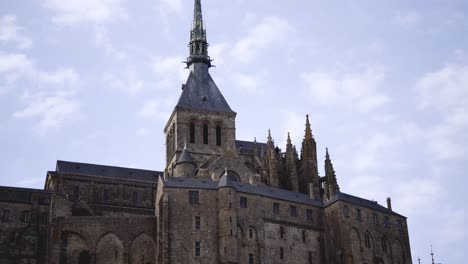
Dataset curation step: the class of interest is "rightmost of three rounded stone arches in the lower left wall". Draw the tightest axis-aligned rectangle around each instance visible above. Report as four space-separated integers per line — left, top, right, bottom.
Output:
130 233 156 264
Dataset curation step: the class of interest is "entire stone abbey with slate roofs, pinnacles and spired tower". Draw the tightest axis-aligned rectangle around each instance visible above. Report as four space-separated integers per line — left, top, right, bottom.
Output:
0 0 412 264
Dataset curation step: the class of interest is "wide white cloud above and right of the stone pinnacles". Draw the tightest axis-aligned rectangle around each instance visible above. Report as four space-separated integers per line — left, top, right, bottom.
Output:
301 69 390 112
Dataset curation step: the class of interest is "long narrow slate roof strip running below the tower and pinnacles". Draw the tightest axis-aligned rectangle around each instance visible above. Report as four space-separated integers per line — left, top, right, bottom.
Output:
164 176 323 206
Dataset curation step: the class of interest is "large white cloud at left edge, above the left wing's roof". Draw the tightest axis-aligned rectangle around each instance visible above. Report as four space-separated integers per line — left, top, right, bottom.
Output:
0 53 80 134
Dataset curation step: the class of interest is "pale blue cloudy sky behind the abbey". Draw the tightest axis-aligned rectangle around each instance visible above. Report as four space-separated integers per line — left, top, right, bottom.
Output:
0 0 468 264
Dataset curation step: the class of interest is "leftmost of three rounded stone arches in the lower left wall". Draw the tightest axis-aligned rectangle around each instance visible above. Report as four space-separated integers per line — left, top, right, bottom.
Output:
60 231 90 264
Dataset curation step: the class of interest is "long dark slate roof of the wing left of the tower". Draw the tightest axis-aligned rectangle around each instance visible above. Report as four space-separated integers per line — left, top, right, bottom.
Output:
56 160 163 183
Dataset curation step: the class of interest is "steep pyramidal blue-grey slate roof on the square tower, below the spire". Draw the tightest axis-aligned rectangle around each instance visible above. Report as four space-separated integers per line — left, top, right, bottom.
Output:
176 70 235 113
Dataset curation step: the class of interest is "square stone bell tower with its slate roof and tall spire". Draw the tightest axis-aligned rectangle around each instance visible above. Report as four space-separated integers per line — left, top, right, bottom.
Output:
164 0 236 176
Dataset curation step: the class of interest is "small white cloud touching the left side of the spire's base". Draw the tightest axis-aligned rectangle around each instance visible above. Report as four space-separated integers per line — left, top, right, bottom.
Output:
151 56 188 88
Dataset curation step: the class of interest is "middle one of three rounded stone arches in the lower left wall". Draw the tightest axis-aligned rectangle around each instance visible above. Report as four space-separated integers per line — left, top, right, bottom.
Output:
96 233 124 264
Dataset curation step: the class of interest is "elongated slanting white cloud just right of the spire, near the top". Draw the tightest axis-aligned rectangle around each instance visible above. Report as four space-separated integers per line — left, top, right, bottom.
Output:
232 16 293 63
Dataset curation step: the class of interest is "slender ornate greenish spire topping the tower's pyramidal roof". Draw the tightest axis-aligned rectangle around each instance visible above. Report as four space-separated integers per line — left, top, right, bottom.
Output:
186 0 211 67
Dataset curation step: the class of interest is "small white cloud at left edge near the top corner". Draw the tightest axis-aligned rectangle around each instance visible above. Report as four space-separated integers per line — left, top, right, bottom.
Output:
0 15 33 49
